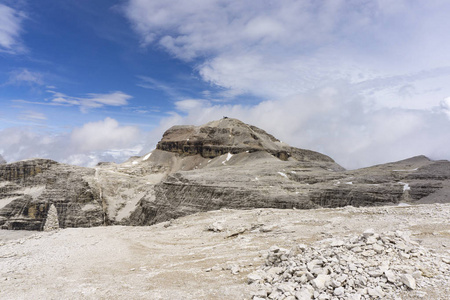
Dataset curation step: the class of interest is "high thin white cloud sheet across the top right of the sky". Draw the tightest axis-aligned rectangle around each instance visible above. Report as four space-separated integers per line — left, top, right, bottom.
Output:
124 0 450 102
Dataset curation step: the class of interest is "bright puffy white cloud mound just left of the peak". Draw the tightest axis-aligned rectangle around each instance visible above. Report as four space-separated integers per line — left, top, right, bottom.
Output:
70 118 139 151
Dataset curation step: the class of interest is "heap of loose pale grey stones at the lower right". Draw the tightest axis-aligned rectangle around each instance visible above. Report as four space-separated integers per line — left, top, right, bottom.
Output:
248 229 450 300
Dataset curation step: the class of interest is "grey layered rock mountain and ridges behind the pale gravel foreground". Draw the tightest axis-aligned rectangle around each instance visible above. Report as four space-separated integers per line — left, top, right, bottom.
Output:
0 118 450 230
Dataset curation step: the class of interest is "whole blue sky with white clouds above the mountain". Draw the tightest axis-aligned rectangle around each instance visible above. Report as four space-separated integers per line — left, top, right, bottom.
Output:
0 0 450 169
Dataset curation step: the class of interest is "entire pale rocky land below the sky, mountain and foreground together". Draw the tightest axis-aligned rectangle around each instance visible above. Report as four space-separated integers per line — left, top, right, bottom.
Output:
0 118 450 300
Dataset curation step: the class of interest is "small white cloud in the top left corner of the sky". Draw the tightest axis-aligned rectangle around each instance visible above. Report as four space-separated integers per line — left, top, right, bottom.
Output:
0 3 25 54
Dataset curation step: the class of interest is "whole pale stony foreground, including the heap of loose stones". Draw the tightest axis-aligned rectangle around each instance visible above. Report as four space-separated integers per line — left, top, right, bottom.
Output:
0 204 450 300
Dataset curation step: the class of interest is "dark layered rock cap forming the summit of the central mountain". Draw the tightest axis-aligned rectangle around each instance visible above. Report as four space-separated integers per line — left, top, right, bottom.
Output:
156 117 333 161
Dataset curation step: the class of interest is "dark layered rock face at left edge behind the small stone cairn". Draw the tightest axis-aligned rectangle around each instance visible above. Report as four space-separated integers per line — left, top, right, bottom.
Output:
0 159 104 230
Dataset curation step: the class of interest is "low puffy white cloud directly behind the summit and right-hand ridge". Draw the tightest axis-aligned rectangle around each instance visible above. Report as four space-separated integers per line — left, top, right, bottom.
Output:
149 81 450 169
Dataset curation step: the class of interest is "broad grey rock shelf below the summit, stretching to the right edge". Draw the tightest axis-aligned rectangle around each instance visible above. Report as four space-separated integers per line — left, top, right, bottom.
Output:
125 152 450 225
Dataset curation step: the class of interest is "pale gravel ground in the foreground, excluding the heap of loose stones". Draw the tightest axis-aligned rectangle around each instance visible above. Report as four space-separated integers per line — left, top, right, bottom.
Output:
0 204 450 299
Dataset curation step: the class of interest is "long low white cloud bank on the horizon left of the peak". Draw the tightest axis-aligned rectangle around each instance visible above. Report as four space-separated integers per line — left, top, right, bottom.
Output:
0 115 144 166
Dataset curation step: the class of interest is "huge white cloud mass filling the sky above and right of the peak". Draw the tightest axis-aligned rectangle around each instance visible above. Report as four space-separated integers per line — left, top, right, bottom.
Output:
123 0 450 168
